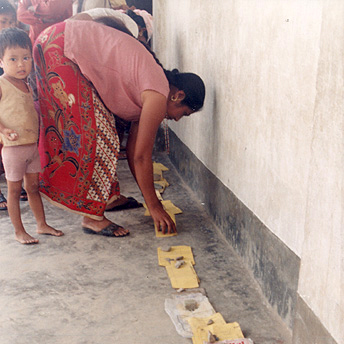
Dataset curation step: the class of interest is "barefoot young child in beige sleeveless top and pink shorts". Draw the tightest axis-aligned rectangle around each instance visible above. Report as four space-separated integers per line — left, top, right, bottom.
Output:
0 28 63 244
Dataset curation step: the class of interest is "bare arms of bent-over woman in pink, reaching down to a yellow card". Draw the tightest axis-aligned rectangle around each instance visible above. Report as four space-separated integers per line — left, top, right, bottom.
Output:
127 91 176 233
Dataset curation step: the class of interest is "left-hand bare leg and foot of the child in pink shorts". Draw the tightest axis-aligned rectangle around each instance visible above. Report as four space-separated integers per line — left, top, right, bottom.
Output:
7 180 38 244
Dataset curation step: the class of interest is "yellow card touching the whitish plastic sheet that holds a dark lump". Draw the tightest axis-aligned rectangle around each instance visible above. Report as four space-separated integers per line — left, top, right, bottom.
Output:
166 262 199 289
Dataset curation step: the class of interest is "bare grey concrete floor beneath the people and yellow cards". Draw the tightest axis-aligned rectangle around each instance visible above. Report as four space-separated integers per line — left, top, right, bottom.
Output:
0 154 291 344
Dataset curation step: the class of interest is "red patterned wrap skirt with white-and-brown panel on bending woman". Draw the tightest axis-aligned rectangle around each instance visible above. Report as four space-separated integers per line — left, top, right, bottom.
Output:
34 23 120 220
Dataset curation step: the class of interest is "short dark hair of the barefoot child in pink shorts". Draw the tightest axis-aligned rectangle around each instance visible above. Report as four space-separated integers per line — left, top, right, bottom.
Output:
0 27 32 59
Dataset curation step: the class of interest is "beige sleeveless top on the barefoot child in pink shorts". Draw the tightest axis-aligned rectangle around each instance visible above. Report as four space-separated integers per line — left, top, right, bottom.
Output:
0 77 38 146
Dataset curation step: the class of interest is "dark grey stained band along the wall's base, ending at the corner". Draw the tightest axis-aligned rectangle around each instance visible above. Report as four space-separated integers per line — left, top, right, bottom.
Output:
163 129 300 329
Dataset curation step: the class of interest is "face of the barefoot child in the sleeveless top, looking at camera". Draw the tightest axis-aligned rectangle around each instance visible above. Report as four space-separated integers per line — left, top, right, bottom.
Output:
0 47 32 79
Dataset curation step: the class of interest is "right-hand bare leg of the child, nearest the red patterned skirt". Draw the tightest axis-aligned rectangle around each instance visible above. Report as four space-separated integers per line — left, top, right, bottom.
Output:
24 173 64 236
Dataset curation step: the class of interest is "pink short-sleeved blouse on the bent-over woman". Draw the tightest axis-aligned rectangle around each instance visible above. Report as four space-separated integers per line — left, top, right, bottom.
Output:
64 20 170 121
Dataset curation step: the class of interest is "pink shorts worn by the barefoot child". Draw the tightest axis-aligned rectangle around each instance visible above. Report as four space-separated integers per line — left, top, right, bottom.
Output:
2 143 41 182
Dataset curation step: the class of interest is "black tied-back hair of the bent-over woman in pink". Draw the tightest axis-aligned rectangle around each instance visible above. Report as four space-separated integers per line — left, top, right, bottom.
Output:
165 69 205 111
